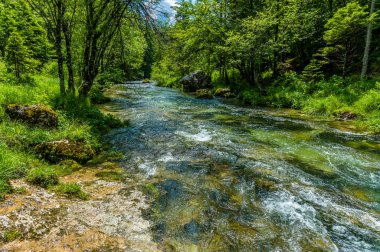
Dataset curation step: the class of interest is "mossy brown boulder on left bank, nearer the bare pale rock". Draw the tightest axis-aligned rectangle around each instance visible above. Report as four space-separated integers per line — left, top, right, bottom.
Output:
36 139 95 164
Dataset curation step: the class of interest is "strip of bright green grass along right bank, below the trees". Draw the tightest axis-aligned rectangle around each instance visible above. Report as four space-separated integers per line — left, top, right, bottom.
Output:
153 72 380 134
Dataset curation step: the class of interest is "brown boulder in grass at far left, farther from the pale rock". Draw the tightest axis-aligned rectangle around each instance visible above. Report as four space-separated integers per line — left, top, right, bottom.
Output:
5 104 58 127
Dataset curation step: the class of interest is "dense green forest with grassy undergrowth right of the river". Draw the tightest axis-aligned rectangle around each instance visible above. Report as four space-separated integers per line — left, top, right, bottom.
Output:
153 0 380 131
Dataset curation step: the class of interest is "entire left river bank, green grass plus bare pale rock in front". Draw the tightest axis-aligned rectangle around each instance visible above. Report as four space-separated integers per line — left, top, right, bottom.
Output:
0 76 156 251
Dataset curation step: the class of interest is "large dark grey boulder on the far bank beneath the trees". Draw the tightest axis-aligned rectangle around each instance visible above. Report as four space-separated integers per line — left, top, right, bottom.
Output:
179 71 212 92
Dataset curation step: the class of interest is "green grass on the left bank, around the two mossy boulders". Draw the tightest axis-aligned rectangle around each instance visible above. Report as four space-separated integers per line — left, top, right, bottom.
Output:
0 76 122 198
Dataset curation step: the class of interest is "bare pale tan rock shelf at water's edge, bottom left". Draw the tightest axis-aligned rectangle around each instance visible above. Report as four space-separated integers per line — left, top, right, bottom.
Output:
0 162 158 251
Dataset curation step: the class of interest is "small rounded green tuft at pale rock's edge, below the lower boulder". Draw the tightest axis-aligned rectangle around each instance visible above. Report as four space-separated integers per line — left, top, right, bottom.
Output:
26 166 59 188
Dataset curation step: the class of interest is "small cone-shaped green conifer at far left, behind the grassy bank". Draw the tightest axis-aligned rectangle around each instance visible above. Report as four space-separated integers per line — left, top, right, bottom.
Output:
6 31 32 79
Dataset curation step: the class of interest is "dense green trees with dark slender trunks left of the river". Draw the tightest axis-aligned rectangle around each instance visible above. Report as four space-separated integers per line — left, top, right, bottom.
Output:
0 0 154 96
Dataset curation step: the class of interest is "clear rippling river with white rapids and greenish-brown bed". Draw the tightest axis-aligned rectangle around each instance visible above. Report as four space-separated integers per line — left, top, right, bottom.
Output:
104 84 380 251
